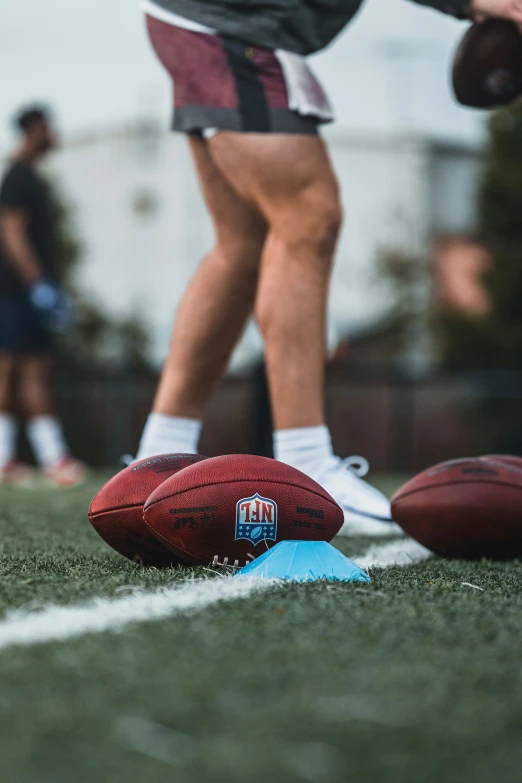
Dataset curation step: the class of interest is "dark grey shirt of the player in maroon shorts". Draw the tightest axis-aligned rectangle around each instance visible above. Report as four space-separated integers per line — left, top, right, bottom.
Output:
147 0 469 54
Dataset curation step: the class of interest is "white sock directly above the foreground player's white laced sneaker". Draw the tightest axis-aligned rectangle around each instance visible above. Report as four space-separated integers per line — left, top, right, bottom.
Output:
274 424 335 478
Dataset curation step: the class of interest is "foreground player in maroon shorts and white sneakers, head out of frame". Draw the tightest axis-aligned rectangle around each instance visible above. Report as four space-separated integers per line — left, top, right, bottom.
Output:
137 0 522 535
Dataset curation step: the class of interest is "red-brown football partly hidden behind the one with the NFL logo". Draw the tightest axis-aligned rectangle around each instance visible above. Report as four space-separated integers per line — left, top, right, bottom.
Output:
89 454 205 568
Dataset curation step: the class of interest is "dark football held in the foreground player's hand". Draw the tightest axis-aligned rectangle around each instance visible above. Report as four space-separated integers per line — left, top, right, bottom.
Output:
453 19 522 109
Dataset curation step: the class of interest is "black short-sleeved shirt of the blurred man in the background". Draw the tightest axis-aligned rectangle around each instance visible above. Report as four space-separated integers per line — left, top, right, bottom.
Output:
0 160 55 296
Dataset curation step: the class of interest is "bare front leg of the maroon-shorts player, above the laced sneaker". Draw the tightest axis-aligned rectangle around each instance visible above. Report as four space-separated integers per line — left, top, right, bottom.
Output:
209 133 341 430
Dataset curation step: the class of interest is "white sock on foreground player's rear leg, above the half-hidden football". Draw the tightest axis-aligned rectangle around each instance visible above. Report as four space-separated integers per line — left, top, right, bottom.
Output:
136 413 202 460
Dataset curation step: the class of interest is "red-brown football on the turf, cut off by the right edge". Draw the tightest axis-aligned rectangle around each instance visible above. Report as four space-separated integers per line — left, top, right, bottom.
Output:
392 456 522 559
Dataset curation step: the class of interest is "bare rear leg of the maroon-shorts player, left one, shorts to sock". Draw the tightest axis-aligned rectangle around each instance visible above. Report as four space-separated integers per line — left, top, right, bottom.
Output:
153 139 266 419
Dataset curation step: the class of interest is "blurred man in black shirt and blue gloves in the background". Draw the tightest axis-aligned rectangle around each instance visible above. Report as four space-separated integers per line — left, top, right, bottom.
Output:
0 106 85 487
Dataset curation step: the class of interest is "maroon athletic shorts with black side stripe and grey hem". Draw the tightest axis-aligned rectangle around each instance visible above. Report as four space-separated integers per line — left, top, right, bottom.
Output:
146 16 333 136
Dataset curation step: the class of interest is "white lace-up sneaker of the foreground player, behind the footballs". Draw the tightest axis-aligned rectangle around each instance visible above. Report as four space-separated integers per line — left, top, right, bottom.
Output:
312 457 403 536
